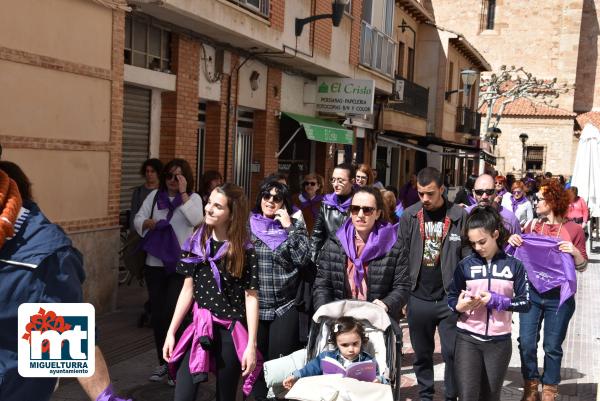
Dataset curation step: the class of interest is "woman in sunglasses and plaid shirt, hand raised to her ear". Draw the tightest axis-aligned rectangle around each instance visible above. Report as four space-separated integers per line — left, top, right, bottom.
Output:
250 181 310 400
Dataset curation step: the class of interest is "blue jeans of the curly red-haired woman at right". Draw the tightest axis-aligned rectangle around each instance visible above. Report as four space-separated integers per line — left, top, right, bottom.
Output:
519 287 575 385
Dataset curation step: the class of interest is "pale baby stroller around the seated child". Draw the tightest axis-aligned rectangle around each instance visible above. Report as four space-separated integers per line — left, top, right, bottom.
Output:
264 299 402 401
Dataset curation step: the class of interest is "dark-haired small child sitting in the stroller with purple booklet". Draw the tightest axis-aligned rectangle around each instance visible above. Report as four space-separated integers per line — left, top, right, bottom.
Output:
283 316 385 390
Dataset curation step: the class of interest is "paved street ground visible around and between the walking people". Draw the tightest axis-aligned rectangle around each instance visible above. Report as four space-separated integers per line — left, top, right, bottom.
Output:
52 248 600 401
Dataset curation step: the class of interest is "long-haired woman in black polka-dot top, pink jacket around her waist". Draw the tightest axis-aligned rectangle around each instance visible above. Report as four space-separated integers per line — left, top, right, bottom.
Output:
163 184 262 401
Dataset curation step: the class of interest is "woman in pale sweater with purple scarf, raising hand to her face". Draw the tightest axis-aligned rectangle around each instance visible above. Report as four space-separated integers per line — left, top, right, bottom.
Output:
133 159 202 384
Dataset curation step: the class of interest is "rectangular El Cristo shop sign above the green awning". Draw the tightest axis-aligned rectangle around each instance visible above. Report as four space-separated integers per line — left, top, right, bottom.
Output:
316 77 375 115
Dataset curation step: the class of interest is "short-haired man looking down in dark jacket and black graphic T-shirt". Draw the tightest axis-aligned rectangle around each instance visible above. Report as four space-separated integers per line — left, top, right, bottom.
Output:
398 167 470 401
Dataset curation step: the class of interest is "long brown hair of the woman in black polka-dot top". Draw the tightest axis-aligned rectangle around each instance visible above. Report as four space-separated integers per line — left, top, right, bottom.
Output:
201 184 249 278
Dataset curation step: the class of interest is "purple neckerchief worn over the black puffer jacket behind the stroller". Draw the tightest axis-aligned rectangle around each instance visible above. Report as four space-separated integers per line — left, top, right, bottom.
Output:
335 219 398 294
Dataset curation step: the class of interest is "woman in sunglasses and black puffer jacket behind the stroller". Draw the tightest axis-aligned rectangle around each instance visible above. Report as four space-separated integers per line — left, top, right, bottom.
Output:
313 187 410 317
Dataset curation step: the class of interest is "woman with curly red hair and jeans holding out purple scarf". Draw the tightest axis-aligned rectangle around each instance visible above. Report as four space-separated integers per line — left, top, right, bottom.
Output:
508 180 588 401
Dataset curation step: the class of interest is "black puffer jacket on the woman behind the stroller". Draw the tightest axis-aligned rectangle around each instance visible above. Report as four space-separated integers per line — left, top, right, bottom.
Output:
313 234 410 316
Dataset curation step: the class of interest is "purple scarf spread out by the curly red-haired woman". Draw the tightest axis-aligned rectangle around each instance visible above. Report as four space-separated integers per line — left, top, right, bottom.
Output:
506 234 577 307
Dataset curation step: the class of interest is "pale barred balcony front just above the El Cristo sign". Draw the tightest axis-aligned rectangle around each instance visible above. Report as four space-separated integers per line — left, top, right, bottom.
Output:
360 21 396 77
